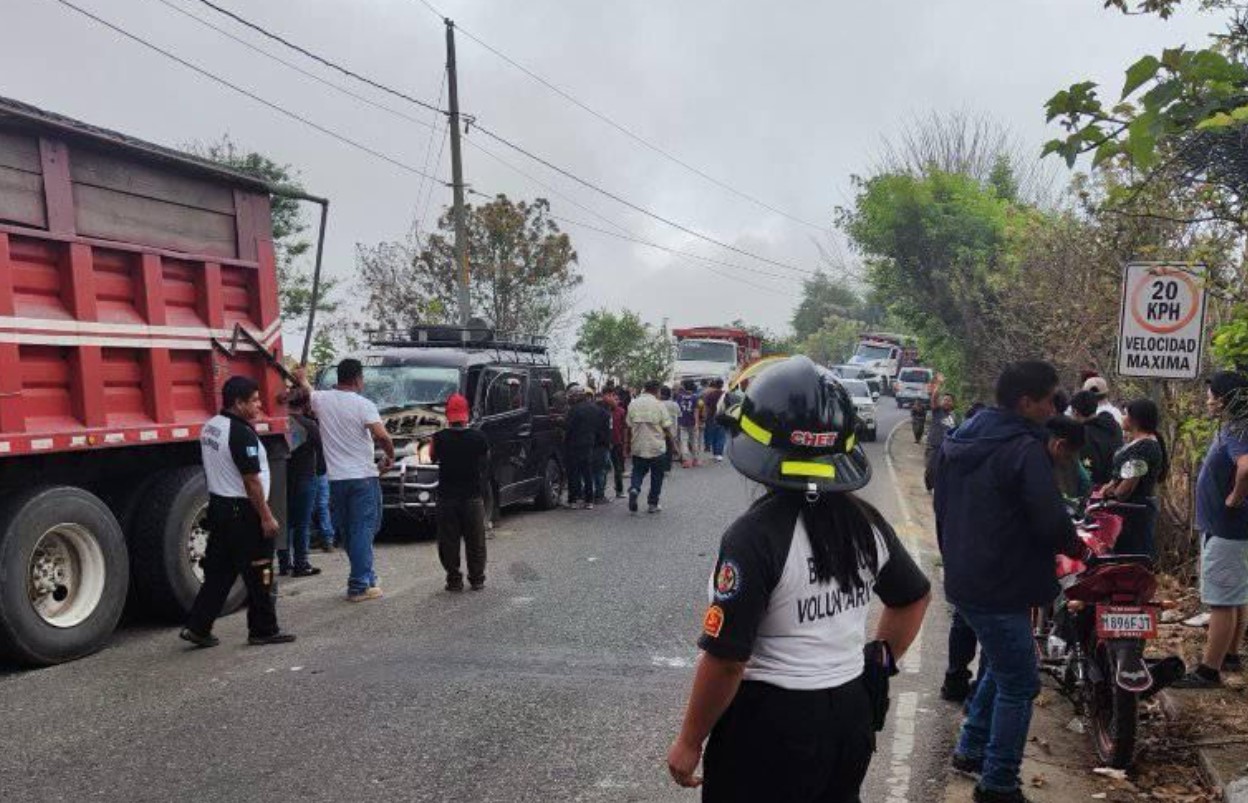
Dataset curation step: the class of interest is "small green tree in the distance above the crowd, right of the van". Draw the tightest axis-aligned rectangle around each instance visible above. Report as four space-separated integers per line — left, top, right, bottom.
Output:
573 310 674 385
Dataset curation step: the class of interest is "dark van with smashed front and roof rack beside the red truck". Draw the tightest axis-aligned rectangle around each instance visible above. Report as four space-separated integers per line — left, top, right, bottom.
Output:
318 327 567 528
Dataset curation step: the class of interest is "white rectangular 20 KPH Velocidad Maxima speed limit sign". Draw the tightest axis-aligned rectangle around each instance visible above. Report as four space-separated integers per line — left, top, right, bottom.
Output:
1118 262 1204 380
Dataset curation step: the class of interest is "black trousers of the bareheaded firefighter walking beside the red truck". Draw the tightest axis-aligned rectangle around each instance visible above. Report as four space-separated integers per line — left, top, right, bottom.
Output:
186 496 278 636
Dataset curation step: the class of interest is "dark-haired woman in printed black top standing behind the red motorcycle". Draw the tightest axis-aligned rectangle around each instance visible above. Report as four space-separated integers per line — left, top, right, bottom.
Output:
1104 398 1169 561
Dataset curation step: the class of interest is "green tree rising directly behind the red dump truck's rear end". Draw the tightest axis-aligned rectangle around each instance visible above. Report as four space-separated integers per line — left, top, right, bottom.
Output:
186 134 338 321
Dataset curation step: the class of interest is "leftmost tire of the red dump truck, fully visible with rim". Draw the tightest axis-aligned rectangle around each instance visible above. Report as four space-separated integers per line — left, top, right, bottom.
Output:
0 486 130 667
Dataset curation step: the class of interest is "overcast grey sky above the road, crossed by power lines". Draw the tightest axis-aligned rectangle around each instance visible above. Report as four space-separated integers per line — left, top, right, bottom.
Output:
0 0 1217 351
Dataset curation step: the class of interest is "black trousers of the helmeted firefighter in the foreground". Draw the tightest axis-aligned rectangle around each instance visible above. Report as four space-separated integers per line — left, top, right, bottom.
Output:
703 679 875 803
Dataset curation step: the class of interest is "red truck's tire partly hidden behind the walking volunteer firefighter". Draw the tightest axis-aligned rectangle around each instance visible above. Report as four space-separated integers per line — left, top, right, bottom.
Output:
130 466 247 622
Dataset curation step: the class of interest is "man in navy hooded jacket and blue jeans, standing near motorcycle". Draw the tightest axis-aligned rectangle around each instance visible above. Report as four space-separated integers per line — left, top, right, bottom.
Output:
935 362 1082 803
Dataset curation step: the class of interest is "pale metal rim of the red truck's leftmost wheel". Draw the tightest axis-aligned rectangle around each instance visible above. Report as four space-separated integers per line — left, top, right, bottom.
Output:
27 523 107 627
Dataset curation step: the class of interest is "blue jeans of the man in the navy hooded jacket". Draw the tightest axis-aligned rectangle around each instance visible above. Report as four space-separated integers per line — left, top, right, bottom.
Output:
957 606 1040 793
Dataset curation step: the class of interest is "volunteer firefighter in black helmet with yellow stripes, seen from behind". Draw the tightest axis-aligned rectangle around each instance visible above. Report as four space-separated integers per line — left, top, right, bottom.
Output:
668 357 930 803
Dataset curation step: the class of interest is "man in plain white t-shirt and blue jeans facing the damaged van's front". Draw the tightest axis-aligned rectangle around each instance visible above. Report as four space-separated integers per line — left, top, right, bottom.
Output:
297 360 394 602
